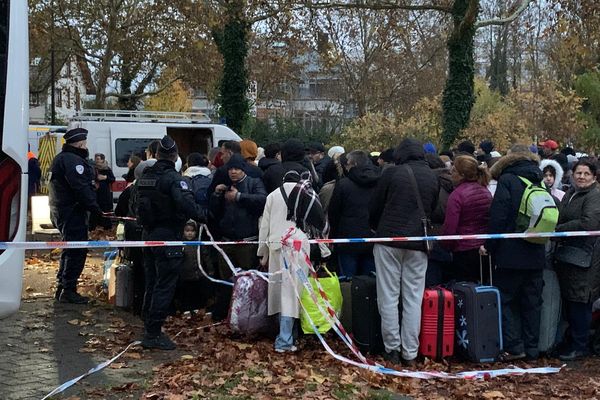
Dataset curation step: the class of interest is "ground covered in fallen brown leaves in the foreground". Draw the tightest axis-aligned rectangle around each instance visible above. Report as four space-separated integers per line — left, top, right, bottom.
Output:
24 242 600 400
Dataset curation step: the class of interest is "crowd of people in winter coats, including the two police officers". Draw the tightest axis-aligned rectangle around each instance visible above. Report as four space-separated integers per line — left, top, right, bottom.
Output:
50 127 600 365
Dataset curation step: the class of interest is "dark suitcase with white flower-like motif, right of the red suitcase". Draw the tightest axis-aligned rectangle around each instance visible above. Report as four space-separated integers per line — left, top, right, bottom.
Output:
452 260 502 363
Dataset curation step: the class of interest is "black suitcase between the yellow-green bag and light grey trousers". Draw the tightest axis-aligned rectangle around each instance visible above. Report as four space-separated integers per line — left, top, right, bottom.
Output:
351 275 383 354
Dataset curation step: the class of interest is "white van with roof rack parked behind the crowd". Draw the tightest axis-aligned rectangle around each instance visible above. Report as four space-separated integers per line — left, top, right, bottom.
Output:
30 110 242 197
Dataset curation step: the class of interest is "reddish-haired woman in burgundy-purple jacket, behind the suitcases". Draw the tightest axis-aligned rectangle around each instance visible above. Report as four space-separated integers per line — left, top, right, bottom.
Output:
443 156 492 282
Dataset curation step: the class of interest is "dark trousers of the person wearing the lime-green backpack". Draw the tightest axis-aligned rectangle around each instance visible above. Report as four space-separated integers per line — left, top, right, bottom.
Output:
494 268 544 357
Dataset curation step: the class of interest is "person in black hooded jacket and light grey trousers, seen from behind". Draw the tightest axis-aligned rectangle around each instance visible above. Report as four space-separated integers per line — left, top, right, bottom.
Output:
369 139 439 366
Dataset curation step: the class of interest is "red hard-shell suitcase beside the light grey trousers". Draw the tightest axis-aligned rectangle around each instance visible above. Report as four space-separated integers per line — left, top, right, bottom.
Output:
419 288 454 360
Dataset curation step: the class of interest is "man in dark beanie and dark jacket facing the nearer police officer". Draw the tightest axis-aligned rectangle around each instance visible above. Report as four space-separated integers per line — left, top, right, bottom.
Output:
209 154 267 321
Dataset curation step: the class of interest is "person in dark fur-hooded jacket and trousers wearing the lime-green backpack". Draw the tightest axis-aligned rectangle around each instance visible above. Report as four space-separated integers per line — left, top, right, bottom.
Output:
482 145 545 361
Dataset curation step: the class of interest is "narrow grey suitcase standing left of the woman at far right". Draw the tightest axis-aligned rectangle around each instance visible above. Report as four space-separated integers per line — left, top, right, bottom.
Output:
538 268 562 354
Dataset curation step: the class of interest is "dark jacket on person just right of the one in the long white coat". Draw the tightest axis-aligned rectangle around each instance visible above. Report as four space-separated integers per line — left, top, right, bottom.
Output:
328 164 380 253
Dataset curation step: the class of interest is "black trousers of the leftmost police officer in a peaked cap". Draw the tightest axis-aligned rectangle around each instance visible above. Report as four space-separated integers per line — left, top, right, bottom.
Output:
56 212 88 290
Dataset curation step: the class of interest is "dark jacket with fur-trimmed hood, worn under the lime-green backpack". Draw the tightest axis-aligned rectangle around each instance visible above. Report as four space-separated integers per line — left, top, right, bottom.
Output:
485 153 545 269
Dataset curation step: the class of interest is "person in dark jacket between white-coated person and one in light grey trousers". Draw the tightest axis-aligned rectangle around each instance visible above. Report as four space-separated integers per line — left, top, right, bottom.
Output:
328 151 380 277
